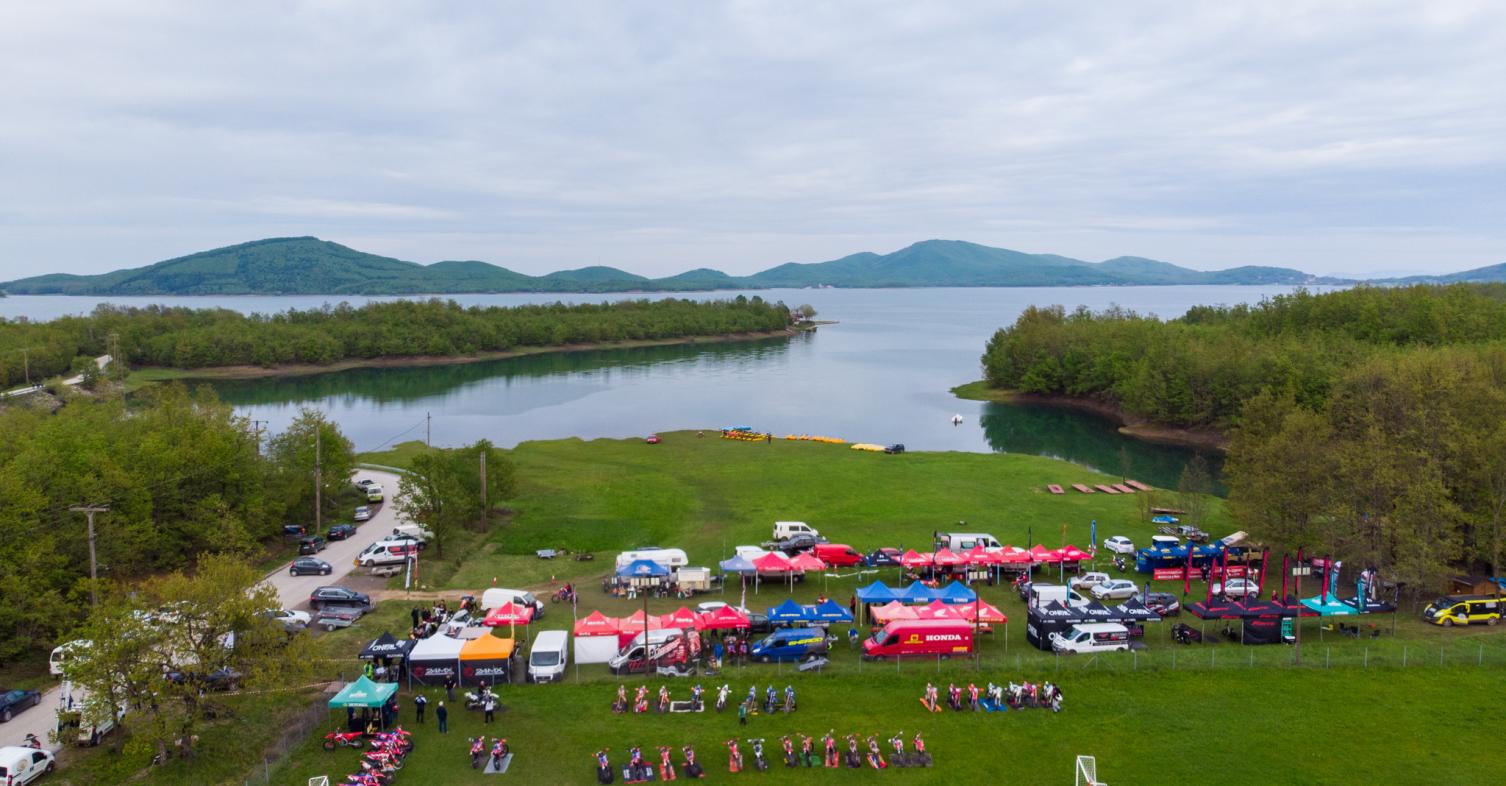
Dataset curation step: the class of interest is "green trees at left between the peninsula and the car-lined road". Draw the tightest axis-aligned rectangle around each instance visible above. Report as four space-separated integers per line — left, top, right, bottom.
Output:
0 384 354 663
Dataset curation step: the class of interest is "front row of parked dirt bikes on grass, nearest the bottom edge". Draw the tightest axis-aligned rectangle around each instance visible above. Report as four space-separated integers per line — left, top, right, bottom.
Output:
595 730 932 783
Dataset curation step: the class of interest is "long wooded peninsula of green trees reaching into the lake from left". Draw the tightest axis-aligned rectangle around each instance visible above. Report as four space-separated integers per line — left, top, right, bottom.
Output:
0 295 791 388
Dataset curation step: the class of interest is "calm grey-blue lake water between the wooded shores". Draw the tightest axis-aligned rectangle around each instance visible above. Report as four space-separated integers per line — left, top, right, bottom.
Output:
0 286 1343 486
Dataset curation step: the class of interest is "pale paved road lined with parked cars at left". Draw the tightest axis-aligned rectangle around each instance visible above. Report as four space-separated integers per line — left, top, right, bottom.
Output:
0 470 399 750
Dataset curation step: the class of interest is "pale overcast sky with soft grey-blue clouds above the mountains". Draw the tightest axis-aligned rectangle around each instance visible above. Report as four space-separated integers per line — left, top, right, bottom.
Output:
0 0 1506 280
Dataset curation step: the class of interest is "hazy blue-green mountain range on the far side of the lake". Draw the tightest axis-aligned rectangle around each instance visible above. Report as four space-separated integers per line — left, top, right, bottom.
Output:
0 238 1337 295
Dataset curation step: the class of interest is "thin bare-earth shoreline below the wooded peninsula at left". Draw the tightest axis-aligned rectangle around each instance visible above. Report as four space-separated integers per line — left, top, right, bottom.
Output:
131 328 809 382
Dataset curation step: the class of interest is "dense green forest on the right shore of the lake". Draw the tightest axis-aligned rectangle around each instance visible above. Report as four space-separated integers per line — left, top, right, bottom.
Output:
983 285 1506 593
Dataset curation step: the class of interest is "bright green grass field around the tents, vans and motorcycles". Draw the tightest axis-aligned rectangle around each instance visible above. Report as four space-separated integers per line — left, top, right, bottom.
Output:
62 432 1506 786
